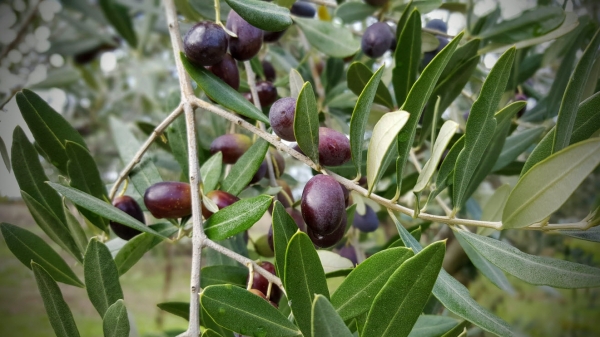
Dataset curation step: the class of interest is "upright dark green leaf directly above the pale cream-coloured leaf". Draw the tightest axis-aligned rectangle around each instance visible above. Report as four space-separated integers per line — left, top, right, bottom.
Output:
392 9 422 105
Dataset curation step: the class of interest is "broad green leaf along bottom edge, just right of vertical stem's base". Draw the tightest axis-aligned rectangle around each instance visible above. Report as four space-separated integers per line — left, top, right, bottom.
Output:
200 285 301 337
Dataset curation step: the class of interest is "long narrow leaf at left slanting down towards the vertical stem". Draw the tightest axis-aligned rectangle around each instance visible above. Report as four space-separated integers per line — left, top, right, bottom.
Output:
48 182 166 239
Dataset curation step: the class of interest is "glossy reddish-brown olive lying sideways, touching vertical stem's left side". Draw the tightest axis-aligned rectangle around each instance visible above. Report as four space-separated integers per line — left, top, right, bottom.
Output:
144 181 192 219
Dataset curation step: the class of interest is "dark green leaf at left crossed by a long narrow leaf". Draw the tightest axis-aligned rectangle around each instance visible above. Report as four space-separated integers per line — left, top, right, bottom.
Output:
66 141 108 232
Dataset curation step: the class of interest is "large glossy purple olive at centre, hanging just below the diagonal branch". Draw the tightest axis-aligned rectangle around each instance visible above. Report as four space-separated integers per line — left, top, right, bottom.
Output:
300 174 346 235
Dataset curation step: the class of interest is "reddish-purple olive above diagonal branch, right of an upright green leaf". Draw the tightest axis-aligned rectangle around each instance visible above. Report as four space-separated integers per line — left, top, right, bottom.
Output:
319 127 352 166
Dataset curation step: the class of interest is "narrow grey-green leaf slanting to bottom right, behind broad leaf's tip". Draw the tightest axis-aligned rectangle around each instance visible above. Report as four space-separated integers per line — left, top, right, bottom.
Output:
390 213 514 336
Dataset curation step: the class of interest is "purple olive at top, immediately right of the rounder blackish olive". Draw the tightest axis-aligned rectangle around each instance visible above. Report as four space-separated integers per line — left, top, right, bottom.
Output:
227 10 263 61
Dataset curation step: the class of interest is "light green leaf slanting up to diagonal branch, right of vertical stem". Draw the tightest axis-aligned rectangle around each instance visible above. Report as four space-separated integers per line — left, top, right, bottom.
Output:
221 138 269 195
